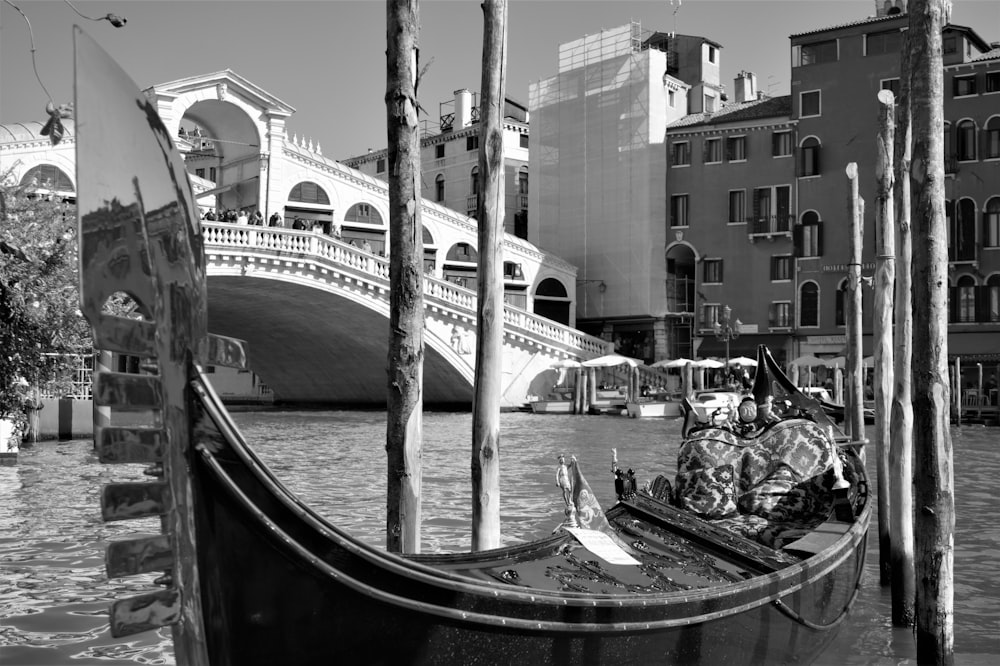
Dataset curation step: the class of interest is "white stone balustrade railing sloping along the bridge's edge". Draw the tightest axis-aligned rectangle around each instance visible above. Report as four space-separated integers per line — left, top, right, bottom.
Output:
201 221 609 358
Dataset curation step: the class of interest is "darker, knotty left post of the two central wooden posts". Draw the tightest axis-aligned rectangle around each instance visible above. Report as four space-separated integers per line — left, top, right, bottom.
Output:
385 0 424 553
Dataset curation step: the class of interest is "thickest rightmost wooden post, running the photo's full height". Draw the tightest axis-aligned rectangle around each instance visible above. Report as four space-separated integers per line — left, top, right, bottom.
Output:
908 0 955 665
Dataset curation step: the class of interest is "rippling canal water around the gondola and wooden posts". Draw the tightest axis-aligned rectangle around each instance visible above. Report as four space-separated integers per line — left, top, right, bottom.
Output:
0 411 1000 666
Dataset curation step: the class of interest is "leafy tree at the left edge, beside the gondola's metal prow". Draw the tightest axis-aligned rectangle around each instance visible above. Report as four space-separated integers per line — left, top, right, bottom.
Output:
0 173 91 434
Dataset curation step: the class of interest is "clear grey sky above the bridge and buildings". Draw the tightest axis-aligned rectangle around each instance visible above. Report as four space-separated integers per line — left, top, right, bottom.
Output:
0 0 1000 159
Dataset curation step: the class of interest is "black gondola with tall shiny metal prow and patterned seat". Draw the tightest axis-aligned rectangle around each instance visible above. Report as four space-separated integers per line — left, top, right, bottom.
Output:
75 29 870 666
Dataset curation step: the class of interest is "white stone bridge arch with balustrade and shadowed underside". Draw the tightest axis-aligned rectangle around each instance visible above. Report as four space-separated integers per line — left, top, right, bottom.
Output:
202 221 611 408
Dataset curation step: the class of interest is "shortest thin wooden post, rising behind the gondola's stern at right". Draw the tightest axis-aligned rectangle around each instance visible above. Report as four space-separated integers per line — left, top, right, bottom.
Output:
844 162 865 458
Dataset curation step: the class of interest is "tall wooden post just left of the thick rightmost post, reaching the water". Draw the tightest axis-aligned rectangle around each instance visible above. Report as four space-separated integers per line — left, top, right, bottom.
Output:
889 32 916 627
